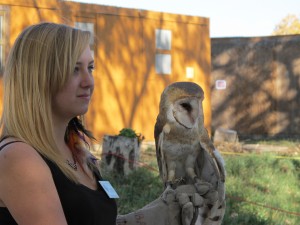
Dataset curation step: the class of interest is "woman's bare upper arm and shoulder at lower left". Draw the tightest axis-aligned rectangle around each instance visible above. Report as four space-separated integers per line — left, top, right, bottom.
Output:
0 143 67 225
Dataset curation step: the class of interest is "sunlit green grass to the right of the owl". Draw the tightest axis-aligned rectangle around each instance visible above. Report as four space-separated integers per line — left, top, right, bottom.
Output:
224 154 300 225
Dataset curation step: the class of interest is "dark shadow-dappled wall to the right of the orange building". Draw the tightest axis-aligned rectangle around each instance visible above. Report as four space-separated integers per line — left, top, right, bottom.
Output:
211 35 300 138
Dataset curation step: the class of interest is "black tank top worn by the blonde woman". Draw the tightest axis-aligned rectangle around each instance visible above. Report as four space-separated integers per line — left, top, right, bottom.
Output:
0 141 117 225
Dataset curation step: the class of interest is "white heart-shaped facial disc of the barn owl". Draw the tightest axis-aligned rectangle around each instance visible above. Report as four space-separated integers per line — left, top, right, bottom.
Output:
172 97 202 129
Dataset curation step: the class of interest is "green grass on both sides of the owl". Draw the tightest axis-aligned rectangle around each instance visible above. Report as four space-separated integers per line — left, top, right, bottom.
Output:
100 149 300 225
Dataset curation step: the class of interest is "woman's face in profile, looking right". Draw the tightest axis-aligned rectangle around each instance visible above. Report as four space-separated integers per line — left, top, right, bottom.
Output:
52 46 94 121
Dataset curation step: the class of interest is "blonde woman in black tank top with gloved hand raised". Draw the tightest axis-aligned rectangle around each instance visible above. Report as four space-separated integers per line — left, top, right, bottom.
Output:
0 23 202 225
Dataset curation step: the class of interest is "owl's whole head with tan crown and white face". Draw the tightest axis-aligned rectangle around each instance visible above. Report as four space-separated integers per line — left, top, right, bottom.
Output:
160 82 204 129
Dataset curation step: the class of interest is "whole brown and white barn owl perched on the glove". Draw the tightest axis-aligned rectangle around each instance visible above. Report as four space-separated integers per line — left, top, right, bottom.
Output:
154 82 225 225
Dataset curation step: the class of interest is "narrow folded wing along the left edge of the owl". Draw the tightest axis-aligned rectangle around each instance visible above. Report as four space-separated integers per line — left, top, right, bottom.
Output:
154 116 167 184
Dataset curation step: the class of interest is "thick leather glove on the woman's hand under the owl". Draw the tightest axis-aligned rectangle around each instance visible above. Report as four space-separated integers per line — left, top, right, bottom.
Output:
117 185 204 225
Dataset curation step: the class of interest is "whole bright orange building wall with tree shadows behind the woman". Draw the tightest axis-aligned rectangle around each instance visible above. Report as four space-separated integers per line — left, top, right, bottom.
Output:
0 0 211 140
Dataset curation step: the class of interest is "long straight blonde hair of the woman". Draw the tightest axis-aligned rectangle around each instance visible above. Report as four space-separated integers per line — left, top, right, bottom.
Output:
0 23 90 182
